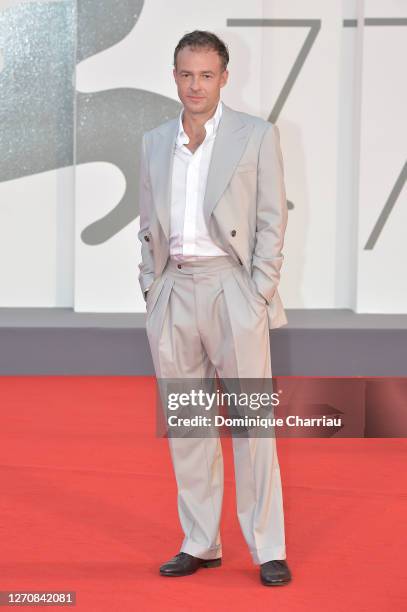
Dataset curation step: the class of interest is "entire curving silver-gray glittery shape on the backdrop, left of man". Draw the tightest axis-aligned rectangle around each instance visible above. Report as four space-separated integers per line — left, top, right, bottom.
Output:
0 0 180 249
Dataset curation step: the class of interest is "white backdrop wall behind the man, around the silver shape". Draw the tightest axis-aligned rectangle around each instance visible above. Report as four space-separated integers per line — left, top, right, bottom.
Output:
0 0 407 313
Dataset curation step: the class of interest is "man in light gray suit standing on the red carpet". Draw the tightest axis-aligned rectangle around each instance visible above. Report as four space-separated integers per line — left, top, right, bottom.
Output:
138 30 291 586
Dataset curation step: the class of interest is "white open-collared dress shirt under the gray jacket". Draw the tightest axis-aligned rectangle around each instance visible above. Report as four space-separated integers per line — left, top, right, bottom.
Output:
170 100 228 261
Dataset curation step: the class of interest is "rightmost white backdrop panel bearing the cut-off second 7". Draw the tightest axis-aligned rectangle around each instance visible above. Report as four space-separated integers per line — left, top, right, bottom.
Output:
355 0 407 313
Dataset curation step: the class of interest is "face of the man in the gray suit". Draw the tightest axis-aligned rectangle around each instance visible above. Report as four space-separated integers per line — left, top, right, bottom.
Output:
173 47 229 114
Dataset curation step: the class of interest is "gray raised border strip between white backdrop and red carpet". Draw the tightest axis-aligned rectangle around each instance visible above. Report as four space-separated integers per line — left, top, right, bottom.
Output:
0 308 407 376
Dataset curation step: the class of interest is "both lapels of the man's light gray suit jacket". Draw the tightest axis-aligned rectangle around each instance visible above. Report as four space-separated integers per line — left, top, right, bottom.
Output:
150 103 252 240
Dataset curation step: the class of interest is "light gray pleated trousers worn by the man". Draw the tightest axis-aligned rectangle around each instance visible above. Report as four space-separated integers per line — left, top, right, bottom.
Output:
146 256 286 564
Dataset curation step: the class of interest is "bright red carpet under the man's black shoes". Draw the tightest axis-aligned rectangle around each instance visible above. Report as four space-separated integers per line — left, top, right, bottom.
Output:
0 376 407 612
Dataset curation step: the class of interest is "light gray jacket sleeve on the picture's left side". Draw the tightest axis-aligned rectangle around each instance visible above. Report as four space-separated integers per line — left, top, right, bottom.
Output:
138 135 154 296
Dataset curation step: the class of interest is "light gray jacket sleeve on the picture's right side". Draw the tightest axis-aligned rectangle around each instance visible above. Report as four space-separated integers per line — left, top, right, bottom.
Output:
252 123 288 303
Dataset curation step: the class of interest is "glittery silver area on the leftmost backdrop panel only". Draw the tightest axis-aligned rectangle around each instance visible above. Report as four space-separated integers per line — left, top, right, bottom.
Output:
0 0 76 181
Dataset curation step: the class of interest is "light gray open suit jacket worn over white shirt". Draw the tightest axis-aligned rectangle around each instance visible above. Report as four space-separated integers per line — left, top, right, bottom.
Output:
138 102 288 328
